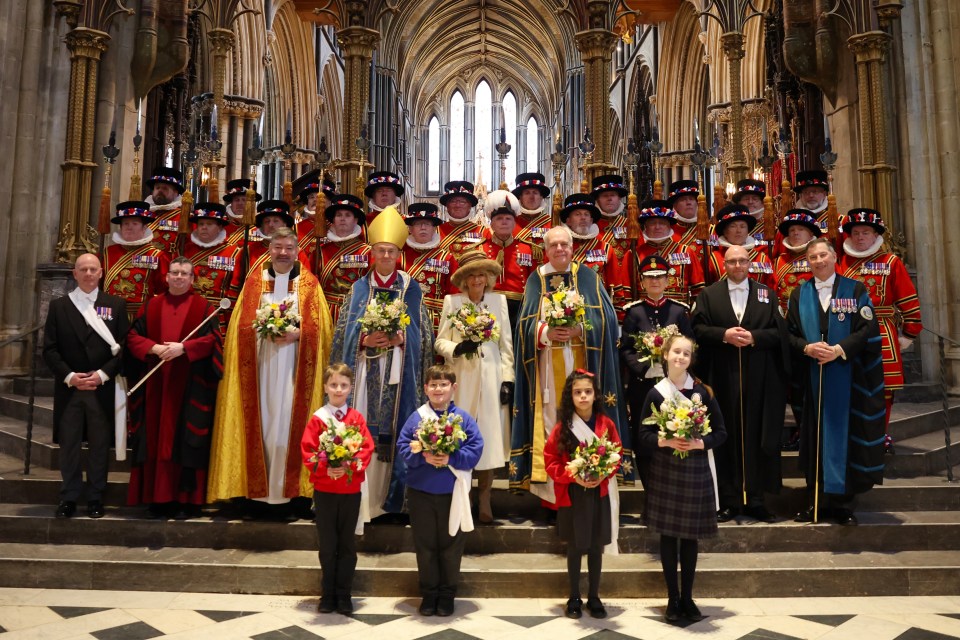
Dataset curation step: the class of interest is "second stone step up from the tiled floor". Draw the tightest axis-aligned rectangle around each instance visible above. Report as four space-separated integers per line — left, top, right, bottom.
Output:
0 505 960 555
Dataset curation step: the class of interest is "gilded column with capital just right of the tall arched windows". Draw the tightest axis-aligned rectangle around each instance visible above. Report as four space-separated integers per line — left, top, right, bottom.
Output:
574 29 618 183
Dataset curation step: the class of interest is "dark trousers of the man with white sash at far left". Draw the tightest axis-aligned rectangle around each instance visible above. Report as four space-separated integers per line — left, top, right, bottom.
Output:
58 390 113 502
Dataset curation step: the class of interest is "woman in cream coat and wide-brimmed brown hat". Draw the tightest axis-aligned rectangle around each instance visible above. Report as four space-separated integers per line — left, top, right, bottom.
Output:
434 250 514 523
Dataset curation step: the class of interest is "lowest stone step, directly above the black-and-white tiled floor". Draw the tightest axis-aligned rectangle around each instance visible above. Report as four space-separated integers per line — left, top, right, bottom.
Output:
0 543 960 598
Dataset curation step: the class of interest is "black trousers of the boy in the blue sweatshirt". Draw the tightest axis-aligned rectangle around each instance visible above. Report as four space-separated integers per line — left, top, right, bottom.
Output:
407 487 465 598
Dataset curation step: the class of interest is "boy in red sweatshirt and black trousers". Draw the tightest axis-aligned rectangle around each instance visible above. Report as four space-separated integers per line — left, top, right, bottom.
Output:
300 363 374 615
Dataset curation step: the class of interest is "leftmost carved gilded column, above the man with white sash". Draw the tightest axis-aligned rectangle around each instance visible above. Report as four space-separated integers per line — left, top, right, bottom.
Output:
57 27 110 262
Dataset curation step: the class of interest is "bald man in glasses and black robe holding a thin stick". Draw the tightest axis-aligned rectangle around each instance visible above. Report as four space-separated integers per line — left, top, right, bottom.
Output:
693 245 789 522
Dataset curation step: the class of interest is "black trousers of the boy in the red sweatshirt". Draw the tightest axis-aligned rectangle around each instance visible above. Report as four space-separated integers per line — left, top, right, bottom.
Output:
313 491 360 596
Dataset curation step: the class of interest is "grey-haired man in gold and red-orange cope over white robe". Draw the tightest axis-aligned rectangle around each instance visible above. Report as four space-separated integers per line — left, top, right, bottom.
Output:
207 228 331 512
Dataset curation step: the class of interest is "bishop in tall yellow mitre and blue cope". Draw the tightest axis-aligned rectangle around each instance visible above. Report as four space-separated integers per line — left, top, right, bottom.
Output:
330 207 433 521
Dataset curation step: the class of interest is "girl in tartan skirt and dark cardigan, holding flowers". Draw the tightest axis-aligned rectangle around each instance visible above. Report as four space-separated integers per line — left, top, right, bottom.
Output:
638 335 727 623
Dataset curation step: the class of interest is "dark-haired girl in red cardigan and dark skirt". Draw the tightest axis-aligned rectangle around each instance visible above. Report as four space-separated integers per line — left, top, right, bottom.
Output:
543 369 620 618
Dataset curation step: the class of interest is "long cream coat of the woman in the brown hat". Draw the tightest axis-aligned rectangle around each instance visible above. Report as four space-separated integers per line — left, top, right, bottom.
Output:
433 292 514 471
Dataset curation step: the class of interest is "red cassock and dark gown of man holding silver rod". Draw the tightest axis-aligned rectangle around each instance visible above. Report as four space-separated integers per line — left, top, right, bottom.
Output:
127 293 222 505
